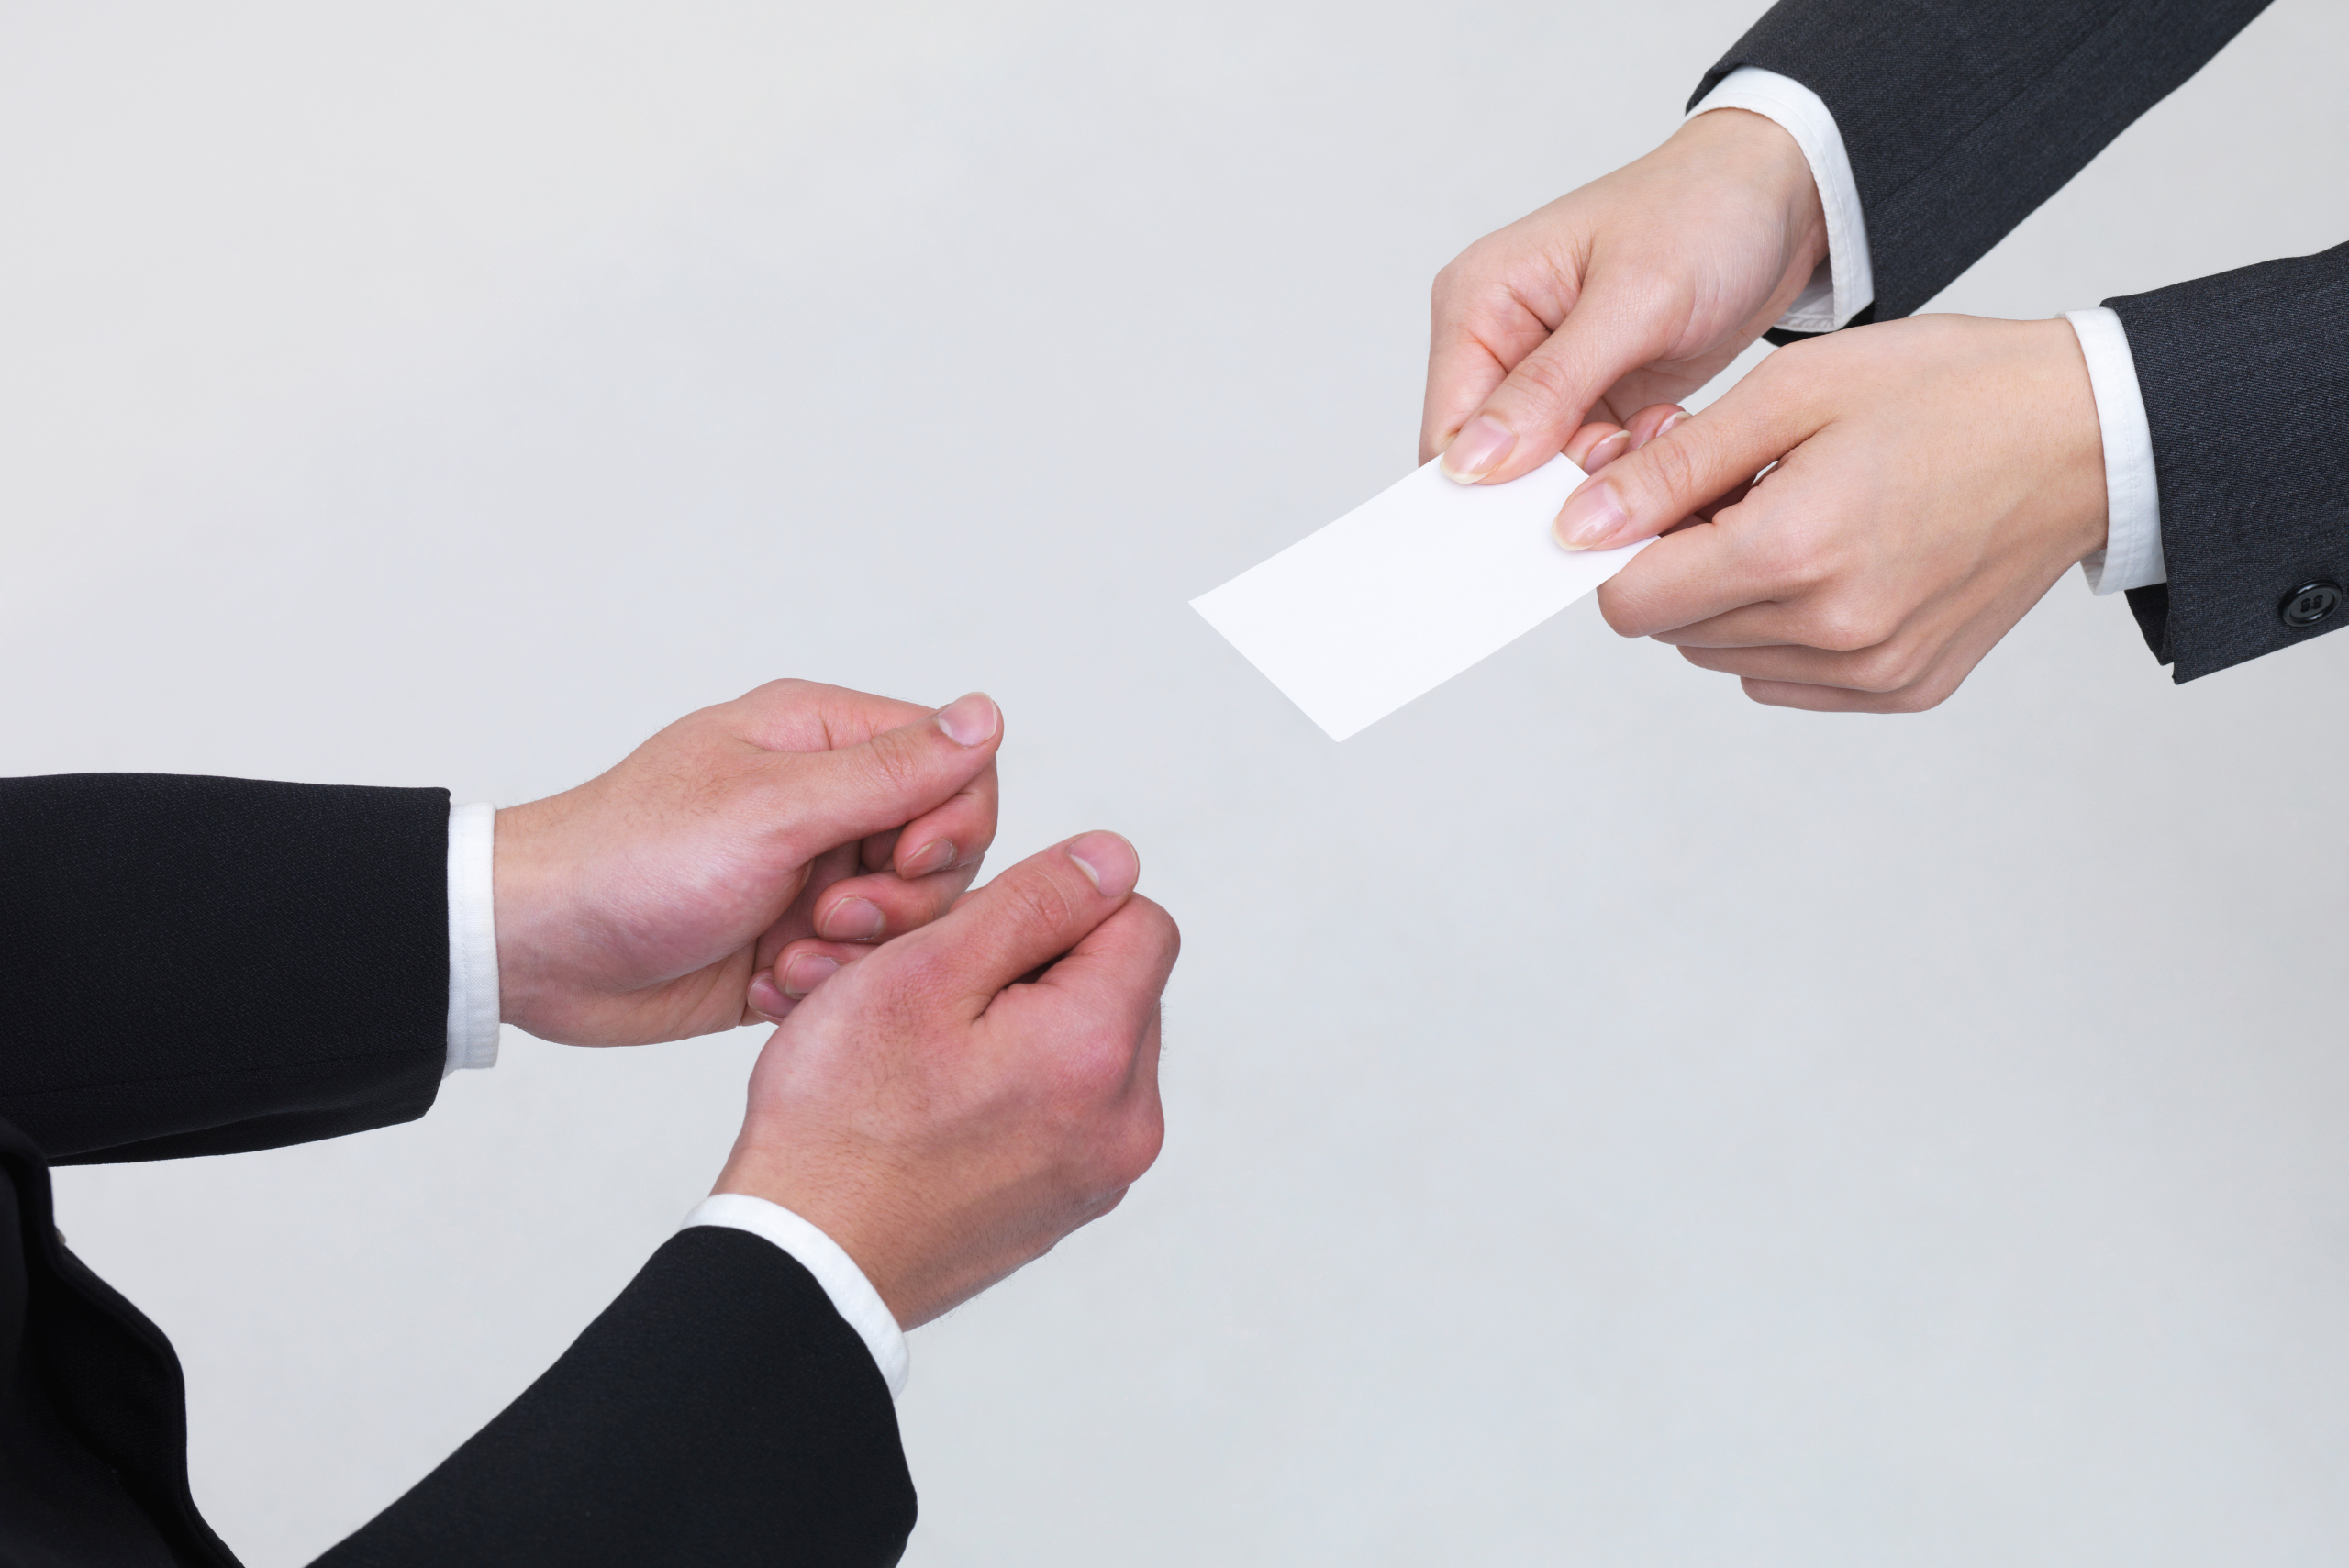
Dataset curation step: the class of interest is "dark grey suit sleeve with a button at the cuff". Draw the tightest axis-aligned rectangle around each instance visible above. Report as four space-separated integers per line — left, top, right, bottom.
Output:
2105 244 2349 681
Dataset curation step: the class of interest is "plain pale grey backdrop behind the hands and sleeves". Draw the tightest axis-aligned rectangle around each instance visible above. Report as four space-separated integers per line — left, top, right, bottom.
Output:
0 0 2349 1568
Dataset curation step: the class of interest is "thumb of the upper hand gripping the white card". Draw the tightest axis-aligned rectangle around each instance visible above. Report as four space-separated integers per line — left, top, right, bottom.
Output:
1442 282 1673 484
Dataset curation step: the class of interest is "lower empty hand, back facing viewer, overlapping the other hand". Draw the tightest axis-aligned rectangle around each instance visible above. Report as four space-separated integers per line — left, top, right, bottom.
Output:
717 833 1179 1329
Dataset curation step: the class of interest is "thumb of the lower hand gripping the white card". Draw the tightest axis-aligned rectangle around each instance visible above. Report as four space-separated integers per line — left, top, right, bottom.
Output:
1551 361 1825 550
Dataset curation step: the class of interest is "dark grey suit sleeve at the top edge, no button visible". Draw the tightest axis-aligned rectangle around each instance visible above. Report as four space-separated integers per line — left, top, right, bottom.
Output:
1689 0 2266 321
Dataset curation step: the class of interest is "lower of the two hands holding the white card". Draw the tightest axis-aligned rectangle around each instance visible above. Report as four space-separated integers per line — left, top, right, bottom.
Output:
1557 317 2105 714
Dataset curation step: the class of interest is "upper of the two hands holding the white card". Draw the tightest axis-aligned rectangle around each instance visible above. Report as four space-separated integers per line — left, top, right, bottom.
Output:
1419 108 1828 484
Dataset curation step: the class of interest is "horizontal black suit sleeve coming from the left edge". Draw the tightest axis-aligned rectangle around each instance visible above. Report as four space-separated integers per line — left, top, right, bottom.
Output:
0 774 449 1164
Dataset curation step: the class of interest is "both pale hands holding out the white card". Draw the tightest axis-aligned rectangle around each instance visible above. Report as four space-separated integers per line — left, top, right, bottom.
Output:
1421 110 2105 714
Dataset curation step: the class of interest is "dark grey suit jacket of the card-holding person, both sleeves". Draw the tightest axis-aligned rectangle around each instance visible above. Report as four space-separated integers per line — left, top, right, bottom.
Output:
1691 0 2349 681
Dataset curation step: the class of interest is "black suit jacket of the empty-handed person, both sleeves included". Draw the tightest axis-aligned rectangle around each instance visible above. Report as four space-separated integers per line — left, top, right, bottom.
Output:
0 774 914 1568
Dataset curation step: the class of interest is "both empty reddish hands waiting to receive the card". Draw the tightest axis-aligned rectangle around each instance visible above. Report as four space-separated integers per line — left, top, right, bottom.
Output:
495 681 1177 1326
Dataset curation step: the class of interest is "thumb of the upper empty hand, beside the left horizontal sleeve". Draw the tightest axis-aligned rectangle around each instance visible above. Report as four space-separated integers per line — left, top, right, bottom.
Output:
775 693 1003 859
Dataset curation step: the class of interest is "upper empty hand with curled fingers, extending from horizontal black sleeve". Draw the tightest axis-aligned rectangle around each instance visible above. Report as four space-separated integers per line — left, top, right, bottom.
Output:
495 681 1003 1044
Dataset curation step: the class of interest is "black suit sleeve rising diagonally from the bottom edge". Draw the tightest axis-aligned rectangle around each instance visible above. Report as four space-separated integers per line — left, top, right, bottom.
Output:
315 1225 914 1568
